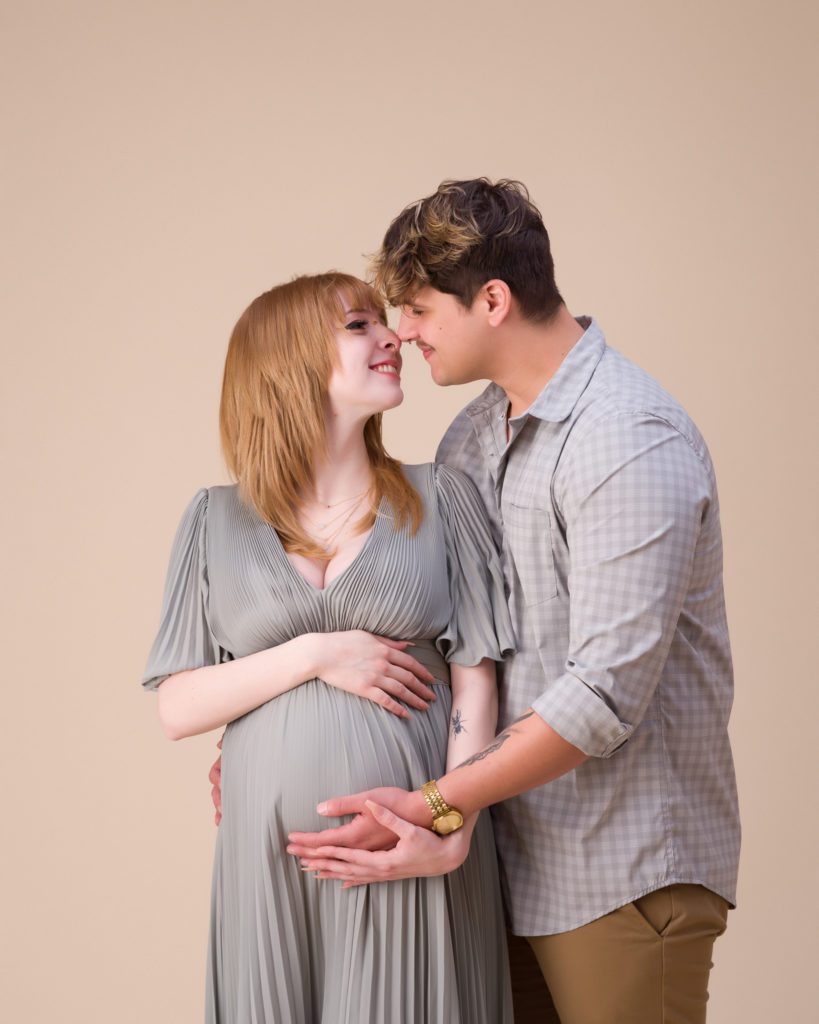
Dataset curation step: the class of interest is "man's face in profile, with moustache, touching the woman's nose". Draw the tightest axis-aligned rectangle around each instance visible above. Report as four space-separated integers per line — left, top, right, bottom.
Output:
396 288 491 386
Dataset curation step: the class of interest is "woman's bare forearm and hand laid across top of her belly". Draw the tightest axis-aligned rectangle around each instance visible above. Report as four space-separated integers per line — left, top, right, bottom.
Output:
158 630 442 741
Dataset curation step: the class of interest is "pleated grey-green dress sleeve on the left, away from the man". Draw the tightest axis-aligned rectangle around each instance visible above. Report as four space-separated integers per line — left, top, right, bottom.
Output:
142 488 226 690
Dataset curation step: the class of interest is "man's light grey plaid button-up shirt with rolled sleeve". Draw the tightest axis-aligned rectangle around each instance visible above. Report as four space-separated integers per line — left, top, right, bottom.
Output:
437 318 739 935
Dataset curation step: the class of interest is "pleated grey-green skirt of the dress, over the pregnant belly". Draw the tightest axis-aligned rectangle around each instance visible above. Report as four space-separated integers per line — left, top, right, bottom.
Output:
206 680 512 1024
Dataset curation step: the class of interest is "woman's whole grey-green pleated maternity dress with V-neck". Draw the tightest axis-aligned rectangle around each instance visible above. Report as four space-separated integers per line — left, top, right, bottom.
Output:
143 464 513 1024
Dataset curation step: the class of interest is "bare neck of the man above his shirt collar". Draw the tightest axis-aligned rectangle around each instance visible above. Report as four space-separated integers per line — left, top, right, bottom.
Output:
492 306 585 419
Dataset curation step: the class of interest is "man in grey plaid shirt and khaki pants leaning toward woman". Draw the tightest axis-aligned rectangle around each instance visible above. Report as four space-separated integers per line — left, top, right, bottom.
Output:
216 179 739 1024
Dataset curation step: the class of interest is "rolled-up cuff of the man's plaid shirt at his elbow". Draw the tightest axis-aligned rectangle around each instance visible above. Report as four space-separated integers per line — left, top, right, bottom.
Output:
531 672 634 758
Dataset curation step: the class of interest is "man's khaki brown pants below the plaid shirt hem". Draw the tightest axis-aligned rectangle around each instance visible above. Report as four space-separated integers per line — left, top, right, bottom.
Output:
509 885 728 1024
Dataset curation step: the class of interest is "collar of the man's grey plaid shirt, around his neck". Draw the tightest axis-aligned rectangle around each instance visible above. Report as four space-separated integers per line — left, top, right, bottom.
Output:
466 316 606 423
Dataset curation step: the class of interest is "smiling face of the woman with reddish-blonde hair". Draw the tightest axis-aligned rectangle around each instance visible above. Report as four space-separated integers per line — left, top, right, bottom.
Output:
328 301 403 420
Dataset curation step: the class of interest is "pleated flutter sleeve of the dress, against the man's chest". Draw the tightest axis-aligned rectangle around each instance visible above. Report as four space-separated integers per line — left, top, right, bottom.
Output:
435 465 515 666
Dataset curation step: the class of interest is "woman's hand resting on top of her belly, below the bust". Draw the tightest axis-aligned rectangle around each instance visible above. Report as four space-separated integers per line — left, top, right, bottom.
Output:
310 630 435 720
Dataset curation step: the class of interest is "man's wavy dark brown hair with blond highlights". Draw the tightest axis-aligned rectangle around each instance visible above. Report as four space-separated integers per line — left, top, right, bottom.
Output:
371 178 563 323
